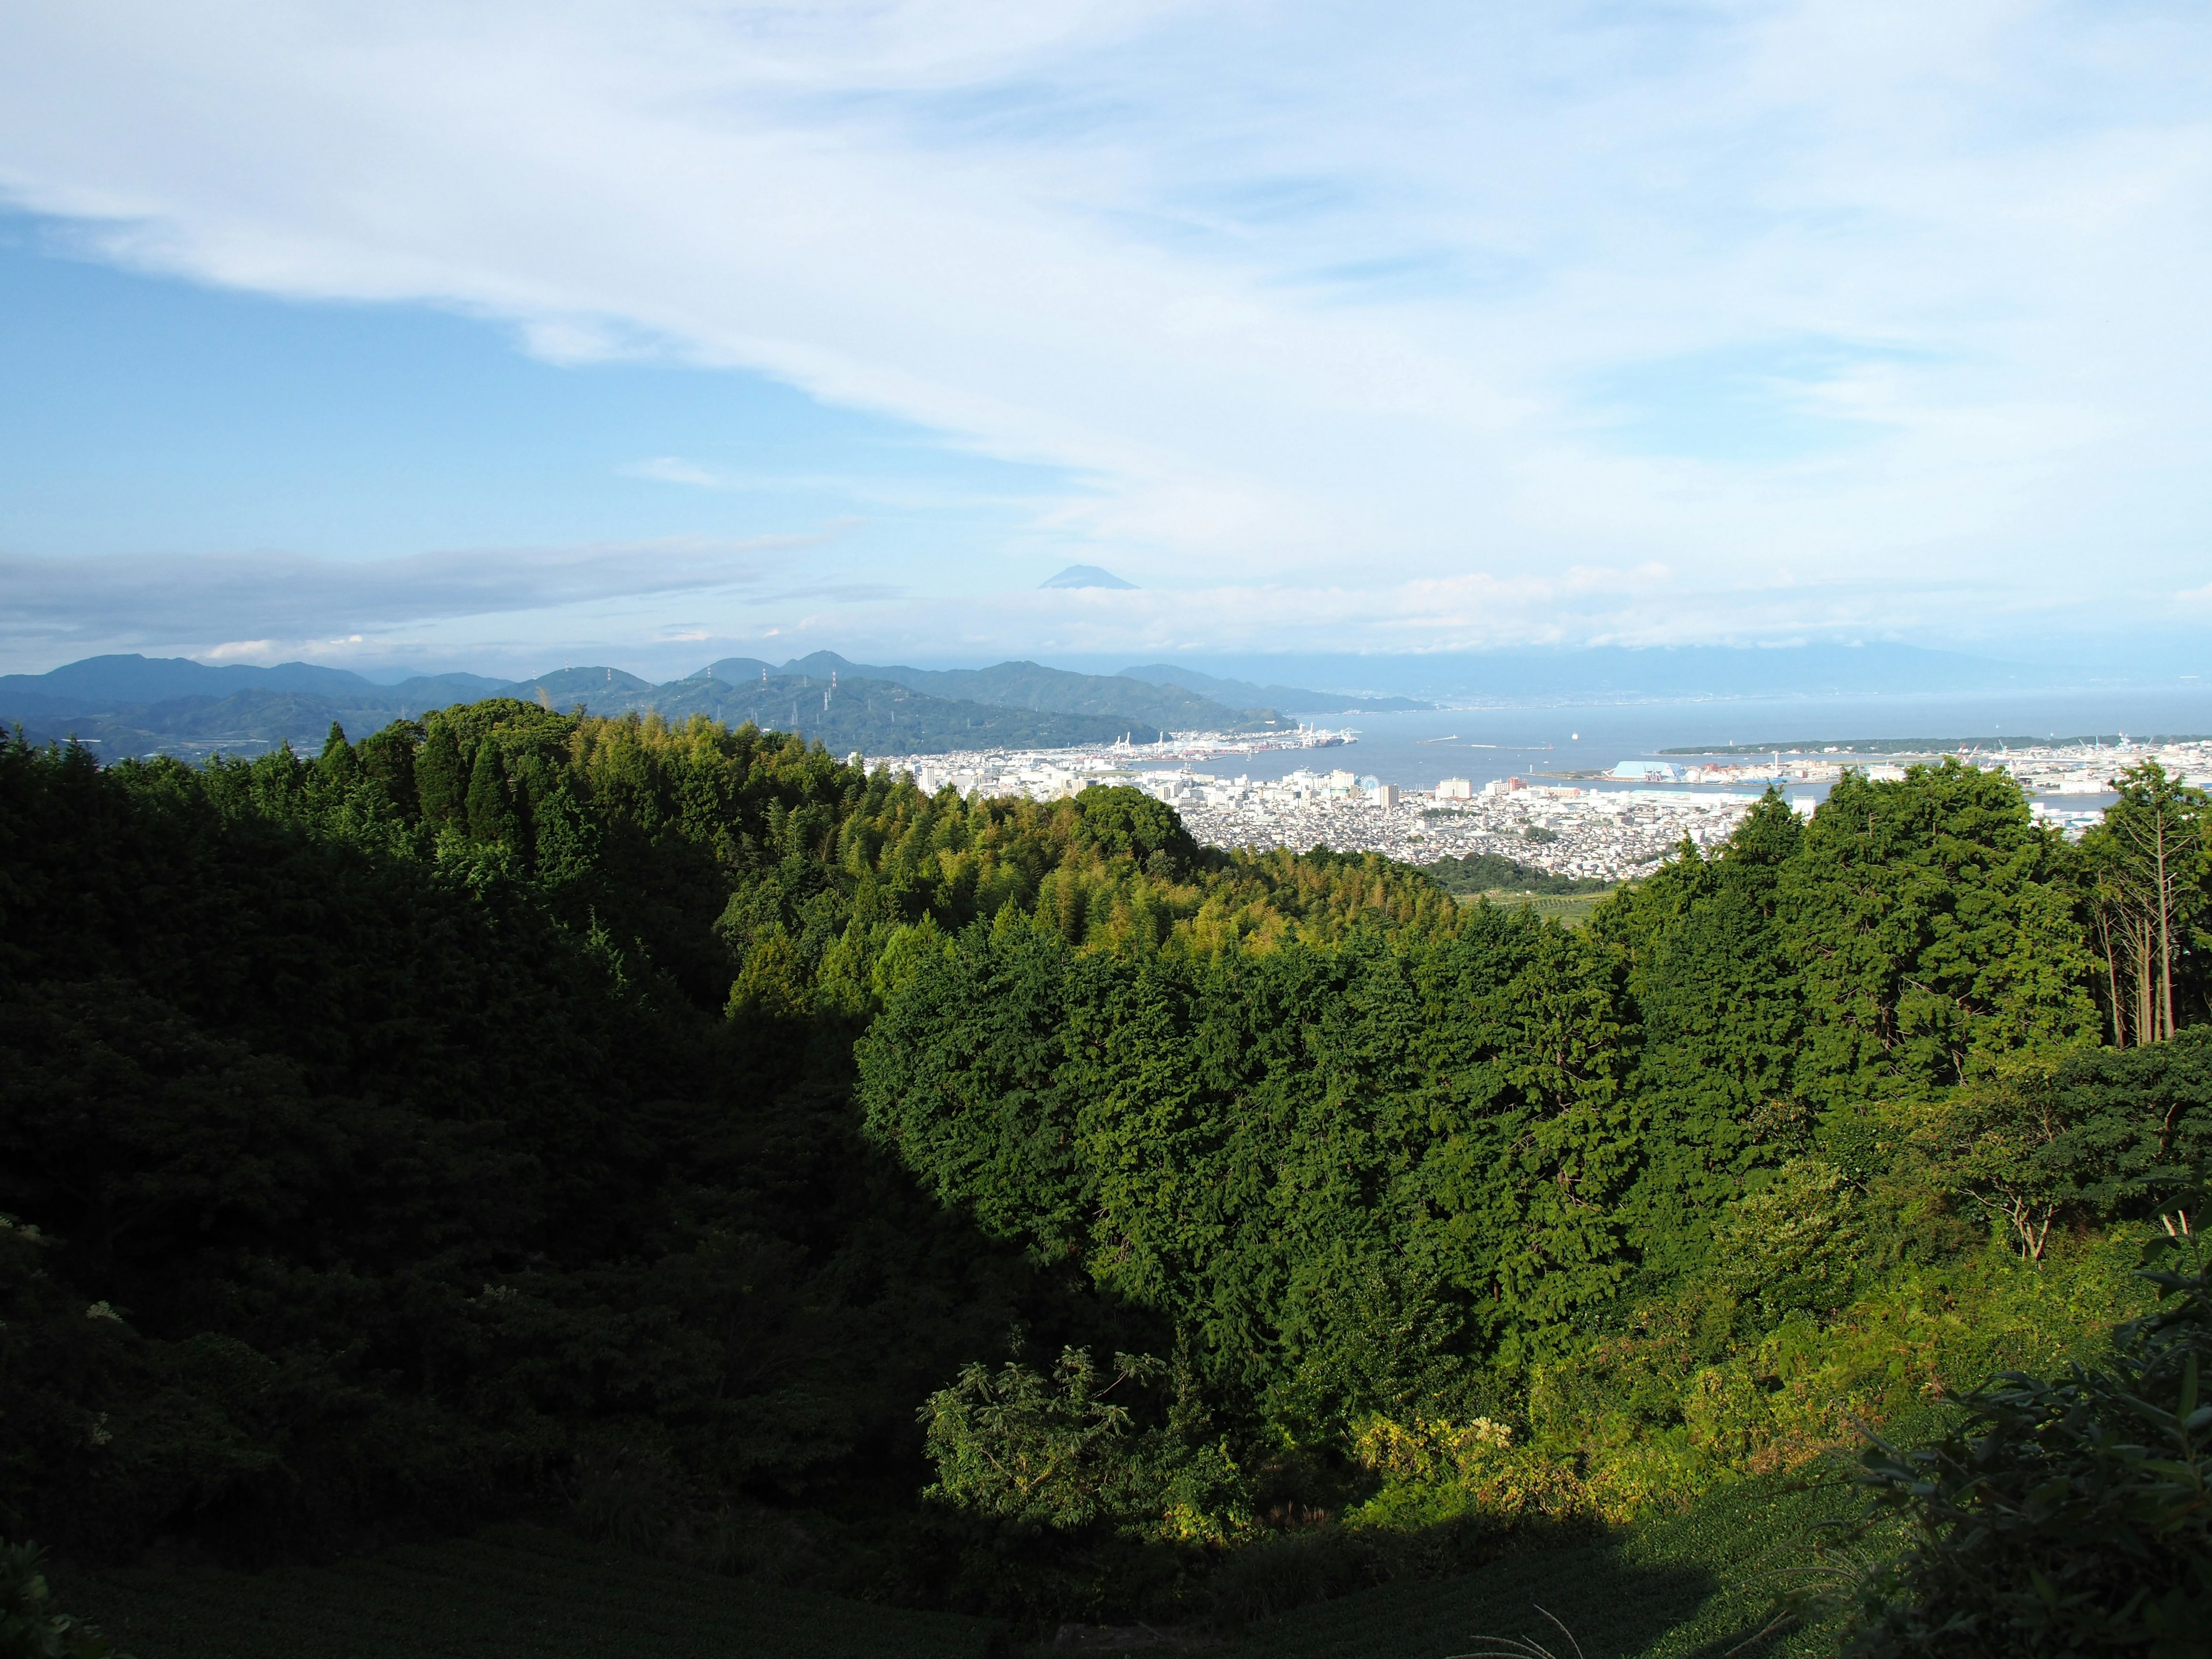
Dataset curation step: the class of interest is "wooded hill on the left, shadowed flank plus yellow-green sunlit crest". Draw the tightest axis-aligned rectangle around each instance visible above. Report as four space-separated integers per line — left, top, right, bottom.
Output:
0 701 1449 1559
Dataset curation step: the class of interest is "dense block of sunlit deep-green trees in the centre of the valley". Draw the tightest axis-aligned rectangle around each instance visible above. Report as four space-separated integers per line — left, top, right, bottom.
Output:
861 911 1630 1429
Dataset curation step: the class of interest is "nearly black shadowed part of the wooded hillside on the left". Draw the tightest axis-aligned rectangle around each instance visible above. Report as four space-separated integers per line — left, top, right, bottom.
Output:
0 725 999 1553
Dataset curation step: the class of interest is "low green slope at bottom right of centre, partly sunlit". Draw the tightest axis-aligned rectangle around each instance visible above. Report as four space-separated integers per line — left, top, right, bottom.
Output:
1243 1478 1858 1659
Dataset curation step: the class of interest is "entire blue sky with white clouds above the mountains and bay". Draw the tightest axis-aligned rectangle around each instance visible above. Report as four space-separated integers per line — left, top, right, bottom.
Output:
0 0 2212 675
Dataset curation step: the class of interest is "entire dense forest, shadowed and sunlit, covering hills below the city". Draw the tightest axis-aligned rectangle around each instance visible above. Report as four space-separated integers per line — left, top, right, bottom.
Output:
0 701 2212 1652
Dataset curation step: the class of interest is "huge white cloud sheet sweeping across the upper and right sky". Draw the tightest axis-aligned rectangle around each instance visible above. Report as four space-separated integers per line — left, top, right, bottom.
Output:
0 0 2212 648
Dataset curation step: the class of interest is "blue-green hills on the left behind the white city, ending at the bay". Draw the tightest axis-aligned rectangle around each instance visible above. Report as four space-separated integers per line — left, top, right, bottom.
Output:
0 653 1292 756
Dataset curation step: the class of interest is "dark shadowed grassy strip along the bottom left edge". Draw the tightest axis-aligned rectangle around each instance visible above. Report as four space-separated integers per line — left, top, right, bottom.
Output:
55 1527 993 1659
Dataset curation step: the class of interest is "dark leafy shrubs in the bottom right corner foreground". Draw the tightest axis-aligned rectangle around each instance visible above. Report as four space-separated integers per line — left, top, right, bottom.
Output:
1854 1212 2212 1657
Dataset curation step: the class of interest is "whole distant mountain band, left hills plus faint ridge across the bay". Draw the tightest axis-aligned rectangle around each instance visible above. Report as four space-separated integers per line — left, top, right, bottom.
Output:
0 643 2084 756
